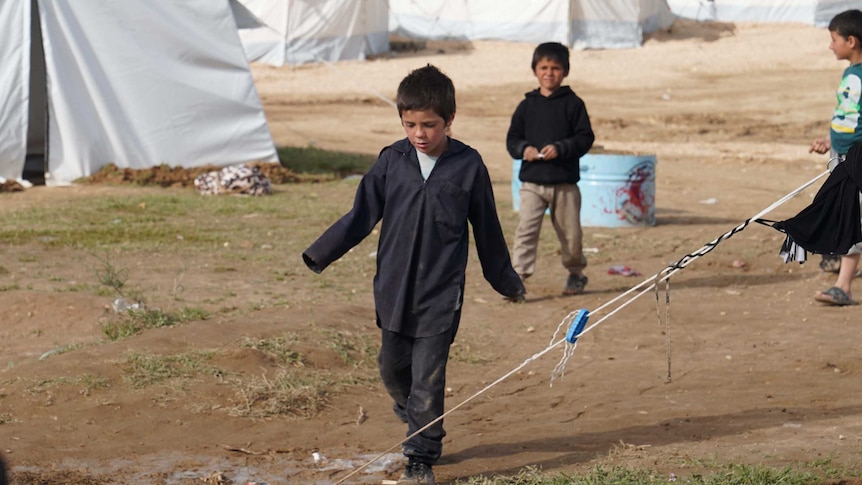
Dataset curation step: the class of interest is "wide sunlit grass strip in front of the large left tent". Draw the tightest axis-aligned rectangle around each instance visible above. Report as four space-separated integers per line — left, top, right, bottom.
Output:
0 189 290 248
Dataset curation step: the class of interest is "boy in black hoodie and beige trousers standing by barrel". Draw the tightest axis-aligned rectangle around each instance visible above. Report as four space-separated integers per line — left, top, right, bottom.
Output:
506 42 595 295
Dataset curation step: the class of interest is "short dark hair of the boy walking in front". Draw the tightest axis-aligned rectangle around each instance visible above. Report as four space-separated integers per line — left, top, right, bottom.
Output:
395 64 455 122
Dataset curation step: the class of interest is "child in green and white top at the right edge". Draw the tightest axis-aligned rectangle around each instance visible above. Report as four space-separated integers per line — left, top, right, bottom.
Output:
809 10 862 306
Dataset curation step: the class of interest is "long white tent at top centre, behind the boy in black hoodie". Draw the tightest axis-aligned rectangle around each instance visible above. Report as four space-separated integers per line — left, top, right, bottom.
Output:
389 0 674 49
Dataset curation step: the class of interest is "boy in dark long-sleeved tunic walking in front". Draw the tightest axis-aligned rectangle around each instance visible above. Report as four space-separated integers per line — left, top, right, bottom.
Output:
302 65 524 485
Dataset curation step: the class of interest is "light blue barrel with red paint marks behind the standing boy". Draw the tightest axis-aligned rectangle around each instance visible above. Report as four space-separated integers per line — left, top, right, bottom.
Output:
512 153 656 227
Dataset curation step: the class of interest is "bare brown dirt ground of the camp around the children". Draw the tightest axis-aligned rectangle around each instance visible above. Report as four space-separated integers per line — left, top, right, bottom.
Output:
0 19 862 484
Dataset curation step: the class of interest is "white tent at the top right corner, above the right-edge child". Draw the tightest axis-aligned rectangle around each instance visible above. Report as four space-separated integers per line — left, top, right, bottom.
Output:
667 0 862 27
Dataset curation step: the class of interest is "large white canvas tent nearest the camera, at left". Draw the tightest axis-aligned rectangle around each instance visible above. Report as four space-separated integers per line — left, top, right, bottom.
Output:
0 0 277 185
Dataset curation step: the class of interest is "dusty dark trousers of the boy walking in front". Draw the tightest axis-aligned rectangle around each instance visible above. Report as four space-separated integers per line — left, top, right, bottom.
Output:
377 310 461 465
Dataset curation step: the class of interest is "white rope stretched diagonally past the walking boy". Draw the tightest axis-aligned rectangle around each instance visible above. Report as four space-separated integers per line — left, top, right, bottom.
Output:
335 170 830 485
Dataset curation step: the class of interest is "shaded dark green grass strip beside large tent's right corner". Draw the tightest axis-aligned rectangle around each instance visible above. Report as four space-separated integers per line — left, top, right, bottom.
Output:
278 147 377 178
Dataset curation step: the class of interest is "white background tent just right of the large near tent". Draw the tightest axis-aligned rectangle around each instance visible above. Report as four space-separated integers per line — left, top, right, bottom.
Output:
231 0 389 66
